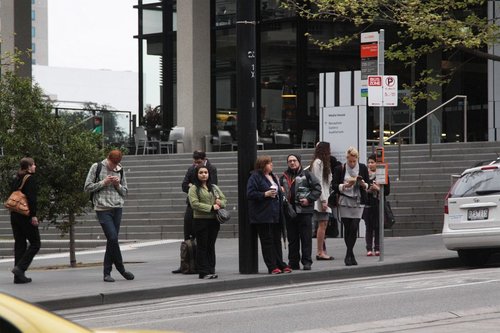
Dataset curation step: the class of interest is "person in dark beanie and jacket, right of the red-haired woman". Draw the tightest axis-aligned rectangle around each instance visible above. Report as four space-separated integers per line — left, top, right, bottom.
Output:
280 154 321 271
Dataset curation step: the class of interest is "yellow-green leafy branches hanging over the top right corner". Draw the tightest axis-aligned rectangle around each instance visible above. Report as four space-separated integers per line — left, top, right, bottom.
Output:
283 0 500 107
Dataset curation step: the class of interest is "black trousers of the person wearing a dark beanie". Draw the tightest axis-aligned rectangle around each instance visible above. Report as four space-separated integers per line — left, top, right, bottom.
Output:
286 214 312 268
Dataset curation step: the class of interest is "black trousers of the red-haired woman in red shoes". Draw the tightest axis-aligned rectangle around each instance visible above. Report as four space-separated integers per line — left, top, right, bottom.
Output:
255 223 286 273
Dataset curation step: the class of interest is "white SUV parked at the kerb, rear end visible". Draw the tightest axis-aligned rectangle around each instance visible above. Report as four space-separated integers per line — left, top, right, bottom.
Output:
443 160 500 266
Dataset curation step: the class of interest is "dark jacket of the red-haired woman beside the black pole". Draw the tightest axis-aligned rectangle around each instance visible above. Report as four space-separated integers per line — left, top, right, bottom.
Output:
247 171 282 223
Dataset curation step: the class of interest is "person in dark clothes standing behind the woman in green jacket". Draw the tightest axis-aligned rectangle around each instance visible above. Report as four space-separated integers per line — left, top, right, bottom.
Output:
172 150 217 274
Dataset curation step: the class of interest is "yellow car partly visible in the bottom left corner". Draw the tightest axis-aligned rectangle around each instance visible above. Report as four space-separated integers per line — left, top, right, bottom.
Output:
0 293 179 333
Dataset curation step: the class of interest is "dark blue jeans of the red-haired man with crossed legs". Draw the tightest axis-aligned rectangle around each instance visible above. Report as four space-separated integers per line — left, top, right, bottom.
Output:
96 208 125 275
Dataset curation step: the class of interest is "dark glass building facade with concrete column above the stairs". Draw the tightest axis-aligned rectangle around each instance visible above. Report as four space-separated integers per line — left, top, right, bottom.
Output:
136 0 500 148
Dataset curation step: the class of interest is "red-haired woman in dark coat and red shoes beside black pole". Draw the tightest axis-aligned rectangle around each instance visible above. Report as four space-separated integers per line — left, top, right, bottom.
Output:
247 156 292 274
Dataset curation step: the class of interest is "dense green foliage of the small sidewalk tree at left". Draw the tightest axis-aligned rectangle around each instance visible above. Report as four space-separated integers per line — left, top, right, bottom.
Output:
0 71 104 232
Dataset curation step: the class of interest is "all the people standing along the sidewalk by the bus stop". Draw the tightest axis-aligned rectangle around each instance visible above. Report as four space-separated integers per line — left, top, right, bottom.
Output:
11 142 390 284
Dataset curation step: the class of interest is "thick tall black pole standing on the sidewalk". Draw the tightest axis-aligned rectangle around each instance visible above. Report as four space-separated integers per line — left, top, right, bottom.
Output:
236 0 259 274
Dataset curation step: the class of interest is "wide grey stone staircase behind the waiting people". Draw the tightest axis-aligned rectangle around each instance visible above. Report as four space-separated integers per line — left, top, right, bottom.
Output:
0 142 500 257
